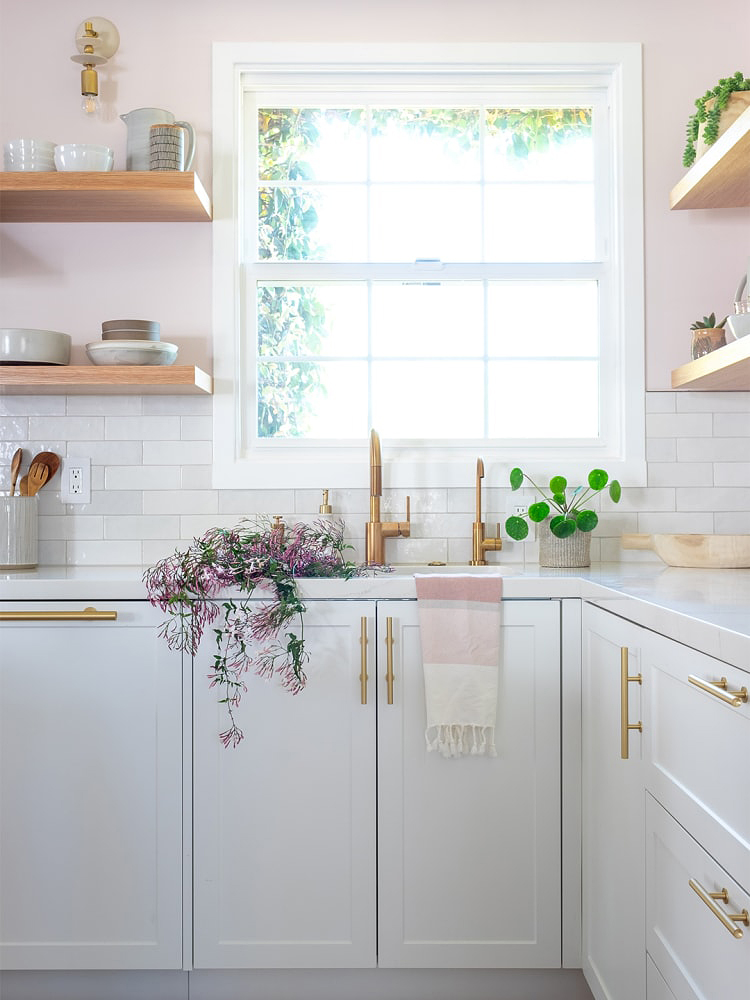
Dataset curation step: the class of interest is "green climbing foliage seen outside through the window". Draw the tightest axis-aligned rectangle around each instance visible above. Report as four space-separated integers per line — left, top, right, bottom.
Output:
257 107 591 438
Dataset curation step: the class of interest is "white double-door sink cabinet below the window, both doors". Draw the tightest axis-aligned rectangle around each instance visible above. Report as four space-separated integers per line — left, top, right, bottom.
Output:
194 601 561 969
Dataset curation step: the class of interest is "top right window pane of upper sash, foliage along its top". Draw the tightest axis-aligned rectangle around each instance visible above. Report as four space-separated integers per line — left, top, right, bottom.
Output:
485 108 594 181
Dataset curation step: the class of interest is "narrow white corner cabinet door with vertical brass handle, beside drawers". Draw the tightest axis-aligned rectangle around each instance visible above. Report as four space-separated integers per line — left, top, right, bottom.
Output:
582 604 648 1000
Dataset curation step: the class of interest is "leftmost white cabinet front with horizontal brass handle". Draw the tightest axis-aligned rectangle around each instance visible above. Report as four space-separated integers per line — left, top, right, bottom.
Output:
0 601 183 969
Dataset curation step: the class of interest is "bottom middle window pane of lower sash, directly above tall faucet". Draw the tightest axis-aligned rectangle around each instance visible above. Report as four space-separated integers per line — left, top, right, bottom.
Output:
372 361 484 440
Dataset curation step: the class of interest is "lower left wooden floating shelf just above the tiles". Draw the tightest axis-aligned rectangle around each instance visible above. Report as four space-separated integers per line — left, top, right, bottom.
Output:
0 365 213 396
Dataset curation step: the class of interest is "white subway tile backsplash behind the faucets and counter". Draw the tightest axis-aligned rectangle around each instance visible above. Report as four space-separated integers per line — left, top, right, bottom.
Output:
0 392 750 566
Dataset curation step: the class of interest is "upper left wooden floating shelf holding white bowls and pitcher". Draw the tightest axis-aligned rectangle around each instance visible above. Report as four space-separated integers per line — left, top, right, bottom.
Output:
0 170 211 222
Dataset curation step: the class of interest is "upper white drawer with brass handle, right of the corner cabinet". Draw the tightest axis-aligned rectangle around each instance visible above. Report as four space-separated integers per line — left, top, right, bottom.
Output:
644 637 750 890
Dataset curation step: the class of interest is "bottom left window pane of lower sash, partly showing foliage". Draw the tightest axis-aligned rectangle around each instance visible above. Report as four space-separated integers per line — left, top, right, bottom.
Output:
257 361 368 438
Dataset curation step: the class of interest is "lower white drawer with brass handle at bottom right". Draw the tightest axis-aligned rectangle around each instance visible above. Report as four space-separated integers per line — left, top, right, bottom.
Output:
646 795 750 1000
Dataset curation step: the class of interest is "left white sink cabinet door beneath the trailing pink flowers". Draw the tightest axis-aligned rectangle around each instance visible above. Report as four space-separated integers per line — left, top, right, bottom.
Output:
194 600 376 969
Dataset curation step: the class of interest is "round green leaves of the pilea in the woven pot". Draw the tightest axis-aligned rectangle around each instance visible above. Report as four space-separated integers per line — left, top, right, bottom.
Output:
505 469 621 542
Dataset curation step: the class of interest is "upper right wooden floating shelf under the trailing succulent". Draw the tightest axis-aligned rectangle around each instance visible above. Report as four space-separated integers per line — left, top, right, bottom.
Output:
669 108 750 209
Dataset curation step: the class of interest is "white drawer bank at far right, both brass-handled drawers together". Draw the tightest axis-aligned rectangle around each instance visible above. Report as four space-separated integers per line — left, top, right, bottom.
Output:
644 624 750 1000
